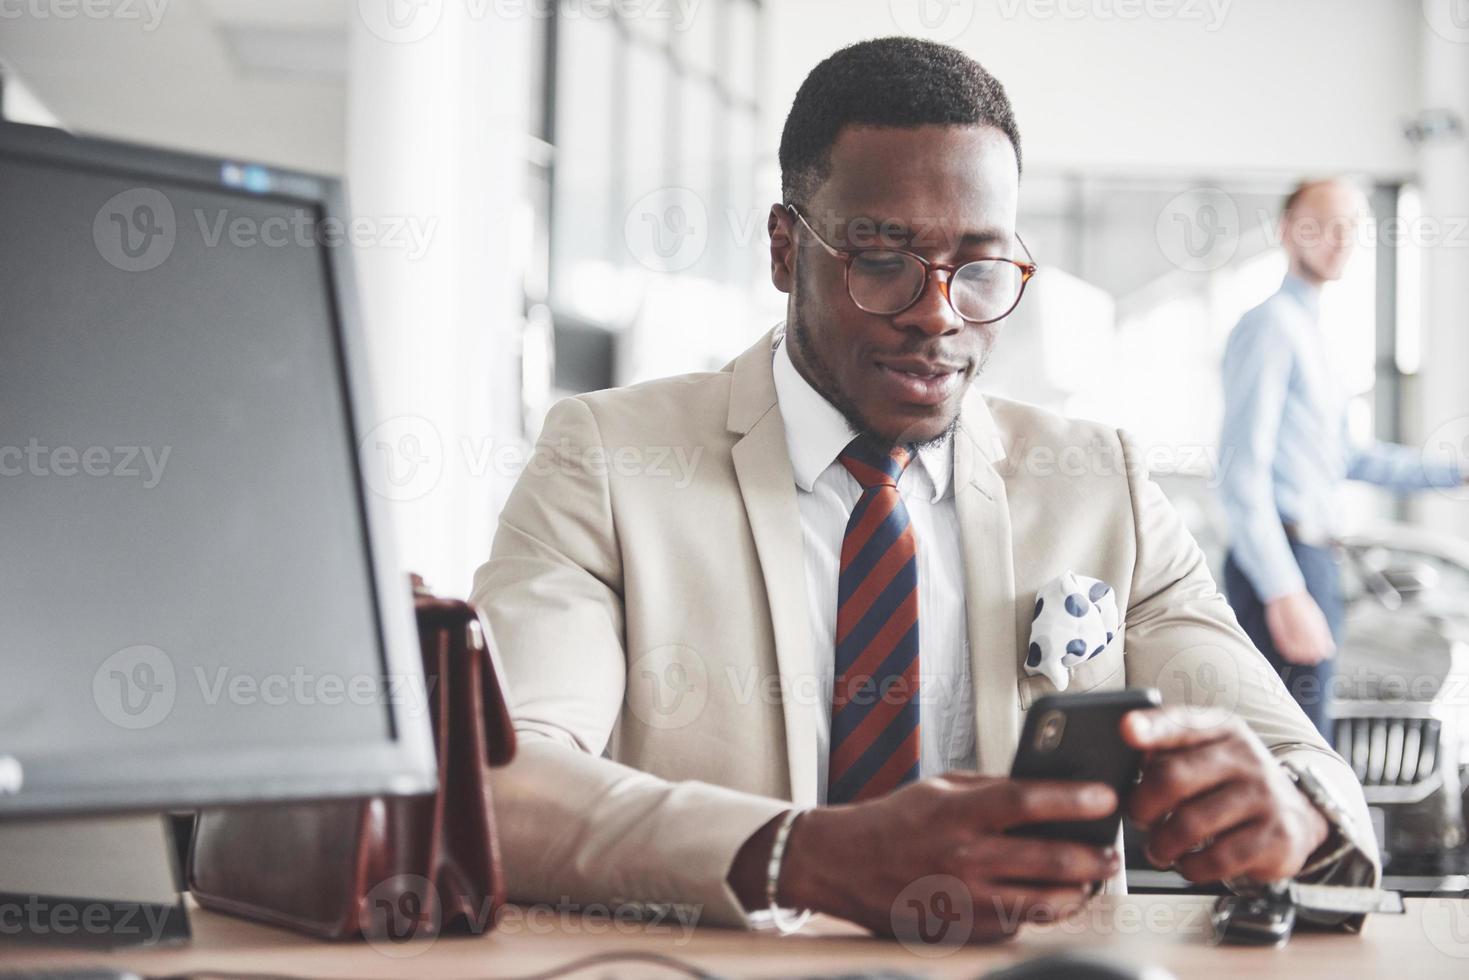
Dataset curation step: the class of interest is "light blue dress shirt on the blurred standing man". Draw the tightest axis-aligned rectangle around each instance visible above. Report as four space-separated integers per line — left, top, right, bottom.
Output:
1219 275 1463 602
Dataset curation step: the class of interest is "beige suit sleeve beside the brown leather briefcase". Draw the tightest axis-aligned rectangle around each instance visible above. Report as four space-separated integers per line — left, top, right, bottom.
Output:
472 398 790 926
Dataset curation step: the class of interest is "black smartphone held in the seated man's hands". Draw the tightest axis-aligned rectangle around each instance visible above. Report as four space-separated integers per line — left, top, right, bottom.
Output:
1009 688 1163 848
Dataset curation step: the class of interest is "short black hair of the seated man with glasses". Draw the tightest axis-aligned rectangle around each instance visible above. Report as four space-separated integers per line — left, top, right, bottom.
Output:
780 37 1019 204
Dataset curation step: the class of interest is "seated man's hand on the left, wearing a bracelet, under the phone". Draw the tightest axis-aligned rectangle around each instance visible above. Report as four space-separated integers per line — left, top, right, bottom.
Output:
730 773 1121 942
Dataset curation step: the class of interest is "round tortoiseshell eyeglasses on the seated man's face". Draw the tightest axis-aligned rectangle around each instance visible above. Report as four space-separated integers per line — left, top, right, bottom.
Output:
786 204 1037 323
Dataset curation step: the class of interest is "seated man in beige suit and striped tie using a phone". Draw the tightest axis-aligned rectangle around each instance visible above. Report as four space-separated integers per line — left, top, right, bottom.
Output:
474 38 1376 937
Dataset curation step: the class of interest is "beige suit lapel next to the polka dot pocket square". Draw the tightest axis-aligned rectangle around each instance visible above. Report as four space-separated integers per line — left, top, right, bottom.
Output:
953 389 1021 776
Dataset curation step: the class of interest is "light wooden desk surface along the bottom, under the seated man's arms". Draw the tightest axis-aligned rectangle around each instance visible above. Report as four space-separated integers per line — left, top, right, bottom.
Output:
0 895 1469 980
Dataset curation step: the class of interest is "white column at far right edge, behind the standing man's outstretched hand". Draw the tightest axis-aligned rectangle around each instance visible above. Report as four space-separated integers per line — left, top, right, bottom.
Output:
1406 7 1469 536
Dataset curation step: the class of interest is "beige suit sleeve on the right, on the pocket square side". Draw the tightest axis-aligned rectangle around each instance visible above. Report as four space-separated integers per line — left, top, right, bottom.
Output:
1119 433 1381 927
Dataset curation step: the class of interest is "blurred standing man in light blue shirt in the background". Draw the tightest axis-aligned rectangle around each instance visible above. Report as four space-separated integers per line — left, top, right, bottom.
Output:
1219 181 1465 739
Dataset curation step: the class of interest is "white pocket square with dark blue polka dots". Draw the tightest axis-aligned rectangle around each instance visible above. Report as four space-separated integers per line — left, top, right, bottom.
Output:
1025 572 1121 691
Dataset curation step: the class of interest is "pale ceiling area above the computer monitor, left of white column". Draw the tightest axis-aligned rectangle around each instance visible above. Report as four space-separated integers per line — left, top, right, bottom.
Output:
0 0 355 173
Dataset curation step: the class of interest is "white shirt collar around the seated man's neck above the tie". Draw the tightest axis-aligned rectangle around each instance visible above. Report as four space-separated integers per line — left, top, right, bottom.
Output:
773 329 953 502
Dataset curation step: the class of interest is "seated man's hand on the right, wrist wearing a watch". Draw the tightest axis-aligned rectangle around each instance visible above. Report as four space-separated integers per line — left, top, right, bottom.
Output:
1122 708 1331 882
